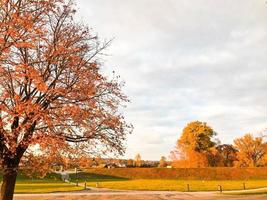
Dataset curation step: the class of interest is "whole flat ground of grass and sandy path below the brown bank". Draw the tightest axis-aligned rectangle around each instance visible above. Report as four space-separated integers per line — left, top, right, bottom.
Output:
1 173 267 200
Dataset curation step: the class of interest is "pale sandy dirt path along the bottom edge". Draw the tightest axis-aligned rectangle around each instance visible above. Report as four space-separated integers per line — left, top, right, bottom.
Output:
14 191 267 200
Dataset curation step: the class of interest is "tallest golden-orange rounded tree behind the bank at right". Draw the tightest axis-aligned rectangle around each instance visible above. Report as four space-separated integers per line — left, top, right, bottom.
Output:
171 121 216 167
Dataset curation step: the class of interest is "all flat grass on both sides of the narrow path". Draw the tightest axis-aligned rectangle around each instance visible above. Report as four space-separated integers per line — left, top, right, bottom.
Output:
1 172 267 194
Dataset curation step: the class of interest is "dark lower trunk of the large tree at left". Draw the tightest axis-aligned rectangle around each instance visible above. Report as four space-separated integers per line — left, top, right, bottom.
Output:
1 167 18 200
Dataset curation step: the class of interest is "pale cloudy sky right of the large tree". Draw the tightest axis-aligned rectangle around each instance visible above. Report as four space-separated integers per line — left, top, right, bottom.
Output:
76 0 267 160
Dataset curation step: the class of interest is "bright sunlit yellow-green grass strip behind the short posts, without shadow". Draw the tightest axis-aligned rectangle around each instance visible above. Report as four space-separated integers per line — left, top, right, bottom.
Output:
85 179 267 191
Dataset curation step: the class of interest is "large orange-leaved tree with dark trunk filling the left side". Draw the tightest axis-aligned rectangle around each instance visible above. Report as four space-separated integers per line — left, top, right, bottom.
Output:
0 0 131 200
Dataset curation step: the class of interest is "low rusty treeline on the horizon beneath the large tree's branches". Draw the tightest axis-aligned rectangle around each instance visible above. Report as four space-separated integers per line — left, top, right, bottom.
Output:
20 152 163 174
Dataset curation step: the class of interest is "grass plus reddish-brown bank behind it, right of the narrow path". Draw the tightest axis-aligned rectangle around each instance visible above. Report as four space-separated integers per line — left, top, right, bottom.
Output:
70 168 267 191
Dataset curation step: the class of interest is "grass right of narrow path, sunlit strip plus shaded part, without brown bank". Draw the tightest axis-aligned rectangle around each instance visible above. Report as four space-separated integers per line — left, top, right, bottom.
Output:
70 172 267 191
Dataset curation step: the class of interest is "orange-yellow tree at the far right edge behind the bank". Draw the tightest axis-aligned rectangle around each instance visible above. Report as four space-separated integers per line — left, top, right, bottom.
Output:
234 134 267 167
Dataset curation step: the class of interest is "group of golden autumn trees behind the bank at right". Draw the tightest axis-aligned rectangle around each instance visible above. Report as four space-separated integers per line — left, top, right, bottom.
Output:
171 121 267 167
